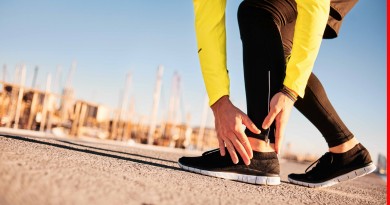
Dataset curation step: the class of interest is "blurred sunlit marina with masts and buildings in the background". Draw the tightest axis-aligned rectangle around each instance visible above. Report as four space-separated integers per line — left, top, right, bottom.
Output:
0 62 387 176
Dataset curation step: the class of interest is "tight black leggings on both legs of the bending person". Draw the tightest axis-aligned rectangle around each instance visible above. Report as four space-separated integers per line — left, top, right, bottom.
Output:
238 0 353 147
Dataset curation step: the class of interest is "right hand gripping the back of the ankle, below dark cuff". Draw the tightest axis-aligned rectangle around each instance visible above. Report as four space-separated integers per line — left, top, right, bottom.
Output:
262 92 294 154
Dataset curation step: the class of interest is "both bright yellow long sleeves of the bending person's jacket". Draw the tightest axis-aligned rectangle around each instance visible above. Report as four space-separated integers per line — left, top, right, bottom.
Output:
193 0 330 105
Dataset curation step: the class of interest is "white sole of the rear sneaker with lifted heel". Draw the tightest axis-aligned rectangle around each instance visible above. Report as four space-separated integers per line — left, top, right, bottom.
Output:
288 163 376 188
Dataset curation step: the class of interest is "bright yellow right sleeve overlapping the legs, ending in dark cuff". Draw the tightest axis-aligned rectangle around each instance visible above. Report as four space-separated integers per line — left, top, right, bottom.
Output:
283 0 330 97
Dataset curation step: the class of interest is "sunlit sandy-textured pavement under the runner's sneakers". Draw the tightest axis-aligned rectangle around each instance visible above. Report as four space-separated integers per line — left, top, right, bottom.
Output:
0 136 386 205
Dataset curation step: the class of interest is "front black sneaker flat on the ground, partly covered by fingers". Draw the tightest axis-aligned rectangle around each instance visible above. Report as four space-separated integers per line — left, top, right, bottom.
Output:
179 149 280 185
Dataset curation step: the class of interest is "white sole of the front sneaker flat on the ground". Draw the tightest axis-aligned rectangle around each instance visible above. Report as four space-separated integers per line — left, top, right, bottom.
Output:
178 163 280 185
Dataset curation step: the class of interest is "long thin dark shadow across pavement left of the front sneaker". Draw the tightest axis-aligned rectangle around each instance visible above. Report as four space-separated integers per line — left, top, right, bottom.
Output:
1 135 184 171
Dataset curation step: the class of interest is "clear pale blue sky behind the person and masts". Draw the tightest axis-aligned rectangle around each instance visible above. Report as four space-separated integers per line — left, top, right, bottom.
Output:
0 0 386 158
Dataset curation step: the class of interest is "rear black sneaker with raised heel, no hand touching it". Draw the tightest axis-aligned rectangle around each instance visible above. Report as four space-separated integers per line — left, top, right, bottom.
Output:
288 144 376 188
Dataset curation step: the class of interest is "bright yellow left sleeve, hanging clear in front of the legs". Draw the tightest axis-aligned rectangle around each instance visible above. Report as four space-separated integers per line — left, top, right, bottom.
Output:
193 0 229 105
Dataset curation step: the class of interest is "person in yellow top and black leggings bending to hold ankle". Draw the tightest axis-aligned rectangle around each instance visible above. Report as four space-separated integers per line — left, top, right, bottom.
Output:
178 0 375 187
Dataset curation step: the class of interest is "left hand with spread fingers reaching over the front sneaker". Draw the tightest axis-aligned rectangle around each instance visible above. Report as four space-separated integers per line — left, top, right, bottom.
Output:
211 96 260 165
